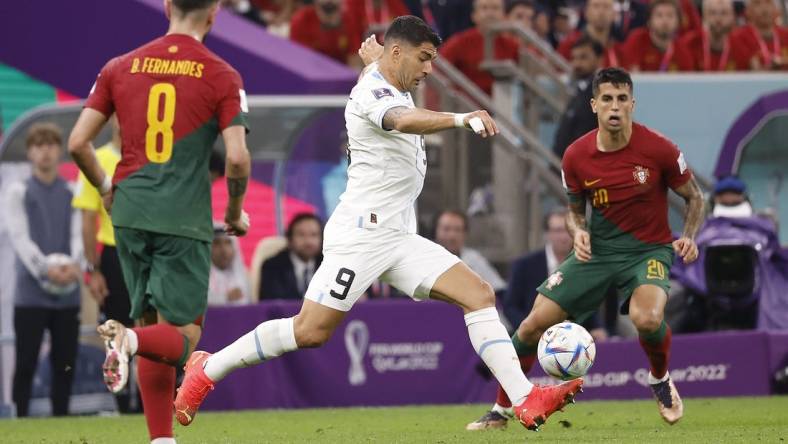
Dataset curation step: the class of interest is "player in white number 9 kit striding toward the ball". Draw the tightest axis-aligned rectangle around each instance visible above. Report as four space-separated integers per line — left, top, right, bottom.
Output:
175 16 582 429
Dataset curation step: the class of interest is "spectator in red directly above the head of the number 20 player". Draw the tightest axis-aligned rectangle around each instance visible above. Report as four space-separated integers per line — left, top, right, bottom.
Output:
558 0 621 68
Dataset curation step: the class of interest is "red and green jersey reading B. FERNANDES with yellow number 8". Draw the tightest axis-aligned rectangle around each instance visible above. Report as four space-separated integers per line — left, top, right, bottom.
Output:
85 34 247 242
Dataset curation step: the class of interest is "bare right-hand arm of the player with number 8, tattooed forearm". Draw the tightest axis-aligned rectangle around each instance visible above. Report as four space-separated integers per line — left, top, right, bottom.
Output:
222 125 251 236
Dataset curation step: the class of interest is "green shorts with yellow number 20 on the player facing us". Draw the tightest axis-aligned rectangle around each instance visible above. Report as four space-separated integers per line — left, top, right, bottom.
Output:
537 245 673 323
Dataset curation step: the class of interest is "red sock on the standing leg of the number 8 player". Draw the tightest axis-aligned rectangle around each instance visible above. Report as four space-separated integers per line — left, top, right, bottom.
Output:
137 357 175 441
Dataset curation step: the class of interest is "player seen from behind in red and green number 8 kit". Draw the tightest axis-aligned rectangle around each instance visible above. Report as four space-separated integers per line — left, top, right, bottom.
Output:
69 0 250 444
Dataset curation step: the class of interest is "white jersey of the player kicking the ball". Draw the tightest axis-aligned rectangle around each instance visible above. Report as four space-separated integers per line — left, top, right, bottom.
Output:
331 65 427 233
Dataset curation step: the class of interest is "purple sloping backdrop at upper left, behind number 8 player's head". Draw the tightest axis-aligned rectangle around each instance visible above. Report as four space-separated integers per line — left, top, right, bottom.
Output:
0 0 358 97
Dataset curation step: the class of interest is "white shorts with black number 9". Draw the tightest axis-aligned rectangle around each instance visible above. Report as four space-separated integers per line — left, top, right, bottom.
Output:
304 222 460 311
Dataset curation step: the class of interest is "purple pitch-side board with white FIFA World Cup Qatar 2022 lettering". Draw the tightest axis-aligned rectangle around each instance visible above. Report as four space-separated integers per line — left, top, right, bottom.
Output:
200 300 788 410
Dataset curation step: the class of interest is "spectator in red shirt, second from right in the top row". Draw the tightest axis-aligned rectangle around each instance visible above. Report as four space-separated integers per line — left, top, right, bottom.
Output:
678 0 750 71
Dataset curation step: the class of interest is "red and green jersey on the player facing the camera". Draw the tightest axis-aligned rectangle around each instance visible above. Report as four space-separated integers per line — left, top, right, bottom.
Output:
562 123 692 253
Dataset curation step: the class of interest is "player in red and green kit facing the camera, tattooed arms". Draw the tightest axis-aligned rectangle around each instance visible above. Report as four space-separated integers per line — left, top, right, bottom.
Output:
468 68 703 430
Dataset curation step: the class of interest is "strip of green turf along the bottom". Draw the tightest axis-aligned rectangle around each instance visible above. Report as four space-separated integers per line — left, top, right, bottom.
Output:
6 396 788 444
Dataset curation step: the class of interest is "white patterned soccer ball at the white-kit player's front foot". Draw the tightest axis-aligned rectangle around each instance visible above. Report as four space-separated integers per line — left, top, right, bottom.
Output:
538 322 596 381
